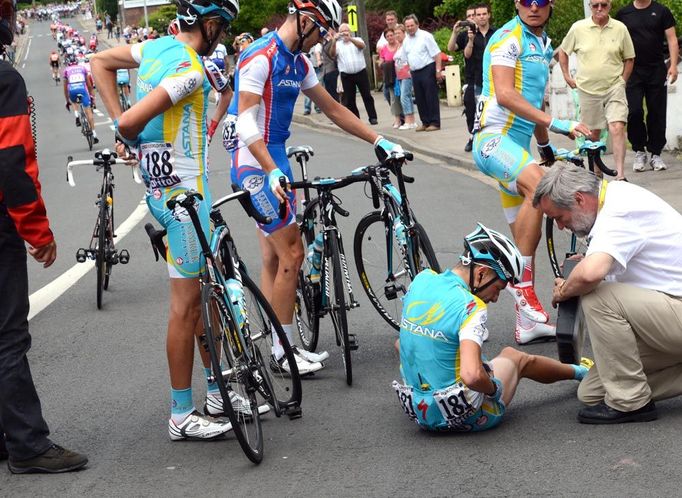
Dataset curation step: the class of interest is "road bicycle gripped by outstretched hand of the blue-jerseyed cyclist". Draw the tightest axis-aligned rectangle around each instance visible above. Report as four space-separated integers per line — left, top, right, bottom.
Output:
353 152 440 330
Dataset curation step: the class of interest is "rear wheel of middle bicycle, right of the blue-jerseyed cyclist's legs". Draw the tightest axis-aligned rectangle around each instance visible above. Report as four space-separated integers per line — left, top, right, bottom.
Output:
294 199 321 351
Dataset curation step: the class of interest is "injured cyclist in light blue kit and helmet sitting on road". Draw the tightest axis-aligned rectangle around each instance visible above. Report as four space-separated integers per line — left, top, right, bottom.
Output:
393 223 591 432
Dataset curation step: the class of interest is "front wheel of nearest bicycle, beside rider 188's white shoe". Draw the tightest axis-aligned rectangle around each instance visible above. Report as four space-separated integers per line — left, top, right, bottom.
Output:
201 283 263 464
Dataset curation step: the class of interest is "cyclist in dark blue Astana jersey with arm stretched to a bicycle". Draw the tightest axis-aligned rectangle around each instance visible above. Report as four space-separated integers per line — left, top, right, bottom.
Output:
223 0 402 374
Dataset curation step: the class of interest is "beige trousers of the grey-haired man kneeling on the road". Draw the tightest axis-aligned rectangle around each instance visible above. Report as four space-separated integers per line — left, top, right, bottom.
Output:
578 282 682 411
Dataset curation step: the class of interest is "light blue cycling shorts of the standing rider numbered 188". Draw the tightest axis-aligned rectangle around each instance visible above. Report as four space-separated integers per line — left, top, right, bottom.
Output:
146 176 211 278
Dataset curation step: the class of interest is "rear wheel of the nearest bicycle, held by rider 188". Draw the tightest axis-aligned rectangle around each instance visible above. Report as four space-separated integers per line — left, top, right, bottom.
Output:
242 272 303 417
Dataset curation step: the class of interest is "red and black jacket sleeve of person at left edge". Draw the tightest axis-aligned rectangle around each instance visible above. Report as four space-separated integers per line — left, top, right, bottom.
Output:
0 61 54 247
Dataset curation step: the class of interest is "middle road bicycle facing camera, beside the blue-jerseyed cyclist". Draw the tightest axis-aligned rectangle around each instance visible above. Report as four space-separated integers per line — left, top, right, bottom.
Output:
280 161 369 386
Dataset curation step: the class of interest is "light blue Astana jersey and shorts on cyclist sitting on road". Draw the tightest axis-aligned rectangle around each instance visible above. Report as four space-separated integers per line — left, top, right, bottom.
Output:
394 270 504 431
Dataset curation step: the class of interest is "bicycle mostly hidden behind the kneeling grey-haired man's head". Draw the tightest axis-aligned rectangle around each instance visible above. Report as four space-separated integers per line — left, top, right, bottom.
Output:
540 140 617 278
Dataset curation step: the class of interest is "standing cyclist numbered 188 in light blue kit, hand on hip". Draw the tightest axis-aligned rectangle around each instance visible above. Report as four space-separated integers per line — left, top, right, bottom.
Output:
92 0 243 441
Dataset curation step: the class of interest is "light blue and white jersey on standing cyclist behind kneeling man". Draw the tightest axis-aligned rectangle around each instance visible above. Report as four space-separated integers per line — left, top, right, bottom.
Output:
474 16 553 149
